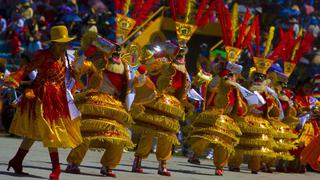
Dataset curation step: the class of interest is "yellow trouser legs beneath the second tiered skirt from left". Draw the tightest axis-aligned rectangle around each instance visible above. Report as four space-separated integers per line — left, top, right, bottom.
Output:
135 135 172 161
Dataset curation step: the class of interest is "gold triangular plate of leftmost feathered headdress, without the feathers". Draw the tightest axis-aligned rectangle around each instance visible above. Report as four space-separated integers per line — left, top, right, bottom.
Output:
116 14 136 43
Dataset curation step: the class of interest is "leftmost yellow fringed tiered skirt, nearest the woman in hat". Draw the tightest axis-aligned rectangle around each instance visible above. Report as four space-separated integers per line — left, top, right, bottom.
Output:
75 90 134 149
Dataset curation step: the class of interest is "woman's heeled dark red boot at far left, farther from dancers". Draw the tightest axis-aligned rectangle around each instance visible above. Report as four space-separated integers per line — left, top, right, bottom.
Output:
7 148 29 175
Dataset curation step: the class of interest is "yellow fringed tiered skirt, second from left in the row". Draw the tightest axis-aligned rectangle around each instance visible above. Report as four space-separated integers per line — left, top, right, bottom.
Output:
131 94 184 145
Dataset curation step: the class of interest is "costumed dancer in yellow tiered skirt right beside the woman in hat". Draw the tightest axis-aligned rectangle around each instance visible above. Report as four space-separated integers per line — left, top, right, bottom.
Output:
66 36 134 177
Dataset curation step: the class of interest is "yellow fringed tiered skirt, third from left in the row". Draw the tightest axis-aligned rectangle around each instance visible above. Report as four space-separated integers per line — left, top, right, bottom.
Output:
185 109 241 153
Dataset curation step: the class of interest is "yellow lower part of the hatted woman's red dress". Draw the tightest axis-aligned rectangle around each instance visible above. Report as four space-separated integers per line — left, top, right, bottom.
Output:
10 100 82 148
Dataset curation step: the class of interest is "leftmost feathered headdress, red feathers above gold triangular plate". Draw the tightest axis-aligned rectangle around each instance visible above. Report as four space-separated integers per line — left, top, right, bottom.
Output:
114 0 159 43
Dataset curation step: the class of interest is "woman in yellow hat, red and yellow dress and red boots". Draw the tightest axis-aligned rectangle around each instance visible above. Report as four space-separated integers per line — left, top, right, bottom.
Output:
5 25 82 180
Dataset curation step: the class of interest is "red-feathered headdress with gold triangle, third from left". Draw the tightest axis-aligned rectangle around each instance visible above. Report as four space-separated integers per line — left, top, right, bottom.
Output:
216 1 258 63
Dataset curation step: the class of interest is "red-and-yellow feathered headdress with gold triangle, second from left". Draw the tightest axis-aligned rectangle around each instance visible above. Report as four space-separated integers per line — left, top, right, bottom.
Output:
169 0 216 44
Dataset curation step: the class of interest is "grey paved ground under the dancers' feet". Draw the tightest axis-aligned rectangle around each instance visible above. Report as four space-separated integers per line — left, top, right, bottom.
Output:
0 137 320 180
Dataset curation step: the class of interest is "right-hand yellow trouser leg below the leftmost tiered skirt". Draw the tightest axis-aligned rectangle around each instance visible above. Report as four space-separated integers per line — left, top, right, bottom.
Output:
100 143 123 169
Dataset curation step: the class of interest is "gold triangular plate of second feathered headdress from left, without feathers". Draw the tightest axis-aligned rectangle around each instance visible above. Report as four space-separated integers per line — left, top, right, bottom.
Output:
176 22 197 44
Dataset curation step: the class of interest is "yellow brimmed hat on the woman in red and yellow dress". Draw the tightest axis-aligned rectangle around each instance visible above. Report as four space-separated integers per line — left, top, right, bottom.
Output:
50 25 76 43
